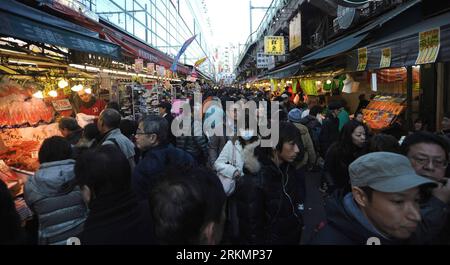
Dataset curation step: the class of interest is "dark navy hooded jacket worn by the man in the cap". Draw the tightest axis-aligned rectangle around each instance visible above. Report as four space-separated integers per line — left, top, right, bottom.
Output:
311 191 407 245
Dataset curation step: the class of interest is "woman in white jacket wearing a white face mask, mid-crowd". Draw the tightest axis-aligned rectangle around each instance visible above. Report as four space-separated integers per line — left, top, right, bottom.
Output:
214 130 257 196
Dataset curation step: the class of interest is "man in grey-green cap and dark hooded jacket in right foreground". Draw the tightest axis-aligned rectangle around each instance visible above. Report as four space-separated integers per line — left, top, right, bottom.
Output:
312 152 436 245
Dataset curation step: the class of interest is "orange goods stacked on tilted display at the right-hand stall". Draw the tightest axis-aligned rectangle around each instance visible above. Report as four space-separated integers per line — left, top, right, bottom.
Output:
363 95 406 131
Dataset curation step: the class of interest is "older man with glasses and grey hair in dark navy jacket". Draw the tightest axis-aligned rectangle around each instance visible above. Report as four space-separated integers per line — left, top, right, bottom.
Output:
132 116 195 199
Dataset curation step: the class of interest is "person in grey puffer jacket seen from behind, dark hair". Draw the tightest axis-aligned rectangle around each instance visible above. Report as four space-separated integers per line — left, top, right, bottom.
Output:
24 136 87 245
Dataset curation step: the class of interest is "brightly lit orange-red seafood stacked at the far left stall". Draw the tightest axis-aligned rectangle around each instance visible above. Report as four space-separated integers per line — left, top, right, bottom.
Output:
0 80 60 171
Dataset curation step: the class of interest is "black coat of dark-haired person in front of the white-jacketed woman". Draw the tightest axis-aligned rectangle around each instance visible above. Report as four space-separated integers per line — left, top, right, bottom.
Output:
244 161 303 245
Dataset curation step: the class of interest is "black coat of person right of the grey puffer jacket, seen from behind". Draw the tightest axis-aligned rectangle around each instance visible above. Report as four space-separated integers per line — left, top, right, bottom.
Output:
80 191 156 245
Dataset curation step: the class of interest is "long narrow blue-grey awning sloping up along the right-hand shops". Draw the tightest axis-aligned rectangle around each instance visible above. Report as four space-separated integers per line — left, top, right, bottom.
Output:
302 0 420 62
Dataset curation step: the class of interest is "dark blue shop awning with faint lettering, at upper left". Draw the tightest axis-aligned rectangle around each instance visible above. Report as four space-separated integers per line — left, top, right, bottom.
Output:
0 0 120 59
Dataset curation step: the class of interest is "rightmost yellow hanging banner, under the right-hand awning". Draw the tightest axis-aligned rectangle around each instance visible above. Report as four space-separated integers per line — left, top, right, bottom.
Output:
416 28 441 64
